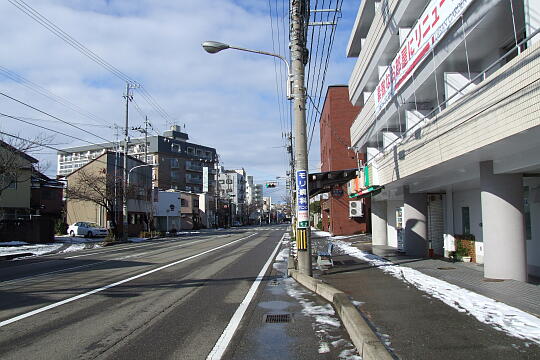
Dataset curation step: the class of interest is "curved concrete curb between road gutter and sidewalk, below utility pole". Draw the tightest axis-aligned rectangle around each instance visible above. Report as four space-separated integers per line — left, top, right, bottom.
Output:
289 269 394 360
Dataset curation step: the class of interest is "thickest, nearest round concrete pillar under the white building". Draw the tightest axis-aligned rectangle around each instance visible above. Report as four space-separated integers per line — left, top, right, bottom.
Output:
480 161 527 281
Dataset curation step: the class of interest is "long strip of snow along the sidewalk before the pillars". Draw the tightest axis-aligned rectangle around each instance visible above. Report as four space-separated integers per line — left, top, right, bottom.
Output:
334 240 540 344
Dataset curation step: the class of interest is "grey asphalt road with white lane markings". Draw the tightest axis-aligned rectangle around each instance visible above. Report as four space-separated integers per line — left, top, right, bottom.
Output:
0 227 292 359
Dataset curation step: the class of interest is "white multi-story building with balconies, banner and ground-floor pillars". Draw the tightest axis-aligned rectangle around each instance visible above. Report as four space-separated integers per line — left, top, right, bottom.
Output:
347 0 540 281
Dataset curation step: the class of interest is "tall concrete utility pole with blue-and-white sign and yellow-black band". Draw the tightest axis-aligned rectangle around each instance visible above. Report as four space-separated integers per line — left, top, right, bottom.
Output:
290 0 312 276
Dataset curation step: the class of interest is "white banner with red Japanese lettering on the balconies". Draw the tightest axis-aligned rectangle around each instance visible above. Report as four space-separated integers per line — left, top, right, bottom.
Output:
373 0 474 115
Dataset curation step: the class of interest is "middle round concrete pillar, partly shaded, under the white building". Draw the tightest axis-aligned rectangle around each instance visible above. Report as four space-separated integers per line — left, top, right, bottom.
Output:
403 187 428 256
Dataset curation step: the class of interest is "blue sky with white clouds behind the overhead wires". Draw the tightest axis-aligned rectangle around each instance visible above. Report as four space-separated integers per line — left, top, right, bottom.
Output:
0 0 360 201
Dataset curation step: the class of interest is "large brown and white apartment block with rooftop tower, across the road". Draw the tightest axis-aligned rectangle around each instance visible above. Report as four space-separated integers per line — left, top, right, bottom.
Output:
57 125 217 193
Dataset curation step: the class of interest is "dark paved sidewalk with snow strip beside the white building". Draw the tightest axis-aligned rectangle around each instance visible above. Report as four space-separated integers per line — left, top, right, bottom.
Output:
313 232 540 359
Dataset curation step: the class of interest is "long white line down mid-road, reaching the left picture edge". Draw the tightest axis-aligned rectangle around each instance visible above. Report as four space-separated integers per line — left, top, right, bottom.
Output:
0 233 257 327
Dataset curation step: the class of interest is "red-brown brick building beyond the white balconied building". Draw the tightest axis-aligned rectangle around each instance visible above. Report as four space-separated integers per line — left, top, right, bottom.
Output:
320 85 370 235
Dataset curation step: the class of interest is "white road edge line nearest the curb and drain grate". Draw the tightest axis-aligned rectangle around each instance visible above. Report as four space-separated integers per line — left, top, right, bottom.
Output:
206 234 285 360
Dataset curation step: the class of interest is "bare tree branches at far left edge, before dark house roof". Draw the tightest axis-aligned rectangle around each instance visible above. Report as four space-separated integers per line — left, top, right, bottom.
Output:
0 134 52 195
